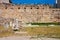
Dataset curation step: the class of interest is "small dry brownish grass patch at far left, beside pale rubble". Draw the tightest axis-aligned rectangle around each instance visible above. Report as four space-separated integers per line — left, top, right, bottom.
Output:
0 26 13 37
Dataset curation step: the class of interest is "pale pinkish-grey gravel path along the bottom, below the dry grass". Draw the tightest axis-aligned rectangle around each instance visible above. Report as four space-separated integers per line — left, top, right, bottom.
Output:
0 36 60 40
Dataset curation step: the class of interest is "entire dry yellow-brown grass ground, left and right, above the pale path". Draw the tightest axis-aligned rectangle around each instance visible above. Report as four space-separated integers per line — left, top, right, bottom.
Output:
0 26 60 38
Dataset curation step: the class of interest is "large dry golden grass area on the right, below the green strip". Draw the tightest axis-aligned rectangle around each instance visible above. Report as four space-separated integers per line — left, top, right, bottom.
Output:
25 26 60 38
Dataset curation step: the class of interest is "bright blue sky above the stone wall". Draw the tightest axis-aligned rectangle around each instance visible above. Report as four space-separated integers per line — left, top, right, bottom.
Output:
11 0 55 4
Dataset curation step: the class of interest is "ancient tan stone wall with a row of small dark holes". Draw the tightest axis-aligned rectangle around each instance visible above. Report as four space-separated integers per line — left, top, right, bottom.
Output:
0 4 60 22
